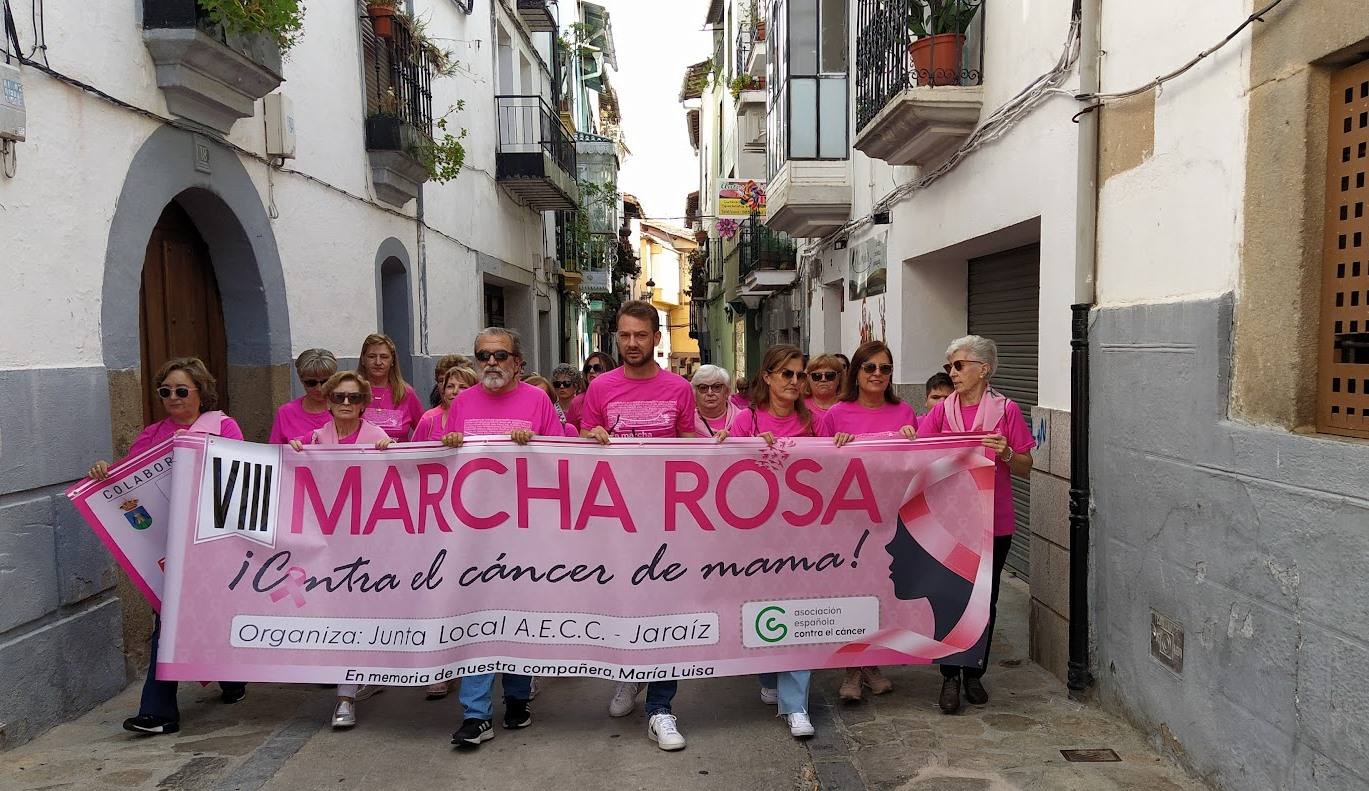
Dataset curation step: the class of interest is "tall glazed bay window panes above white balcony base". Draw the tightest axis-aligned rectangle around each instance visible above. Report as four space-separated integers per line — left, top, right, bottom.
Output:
767 0 850 175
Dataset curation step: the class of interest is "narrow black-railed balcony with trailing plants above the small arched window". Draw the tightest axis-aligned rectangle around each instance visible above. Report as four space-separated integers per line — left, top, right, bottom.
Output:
361 22 433 207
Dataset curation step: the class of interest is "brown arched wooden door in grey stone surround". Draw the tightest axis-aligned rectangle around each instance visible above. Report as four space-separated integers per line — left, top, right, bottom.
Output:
138 203 229 423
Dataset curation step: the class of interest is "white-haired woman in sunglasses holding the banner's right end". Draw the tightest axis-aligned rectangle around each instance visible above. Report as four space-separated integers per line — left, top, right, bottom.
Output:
919 335 1036 714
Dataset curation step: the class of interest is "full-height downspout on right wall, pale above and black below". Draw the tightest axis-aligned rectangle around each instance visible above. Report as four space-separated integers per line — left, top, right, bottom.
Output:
1066 0 1102 698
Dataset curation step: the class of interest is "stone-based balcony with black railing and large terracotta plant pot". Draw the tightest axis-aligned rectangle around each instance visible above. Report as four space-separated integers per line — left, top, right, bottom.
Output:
856 0 984 166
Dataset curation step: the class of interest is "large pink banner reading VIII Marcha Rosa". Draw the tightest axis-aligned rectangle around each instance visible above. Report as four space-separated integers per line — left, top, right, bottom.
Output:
157 435 994 684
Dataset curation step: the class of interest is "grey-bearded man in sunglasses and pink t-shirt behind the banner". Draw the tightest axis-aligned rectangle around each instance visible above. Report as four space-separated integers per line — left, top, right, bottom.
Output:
442 327 565 747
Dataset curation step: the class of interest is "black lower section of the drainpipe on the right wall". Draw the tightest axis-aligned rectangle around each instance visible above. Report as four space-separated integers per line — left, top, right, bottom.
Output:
1068 302 1094 697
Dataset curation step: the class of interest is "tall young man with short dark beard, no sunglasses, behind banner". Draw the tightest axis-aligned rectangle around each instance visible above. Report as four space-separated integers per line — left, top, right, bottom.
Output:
580 300 695 750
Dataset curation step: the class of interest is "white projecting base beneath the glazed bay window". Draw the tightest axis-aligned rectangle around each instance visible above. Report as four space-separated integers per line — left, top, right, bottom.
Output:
765 159 852 238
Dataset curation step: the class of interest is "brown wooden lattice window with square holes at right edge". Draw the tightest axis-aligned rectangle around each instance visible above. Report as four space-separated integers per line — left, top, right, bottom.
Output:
1317 60 1369 438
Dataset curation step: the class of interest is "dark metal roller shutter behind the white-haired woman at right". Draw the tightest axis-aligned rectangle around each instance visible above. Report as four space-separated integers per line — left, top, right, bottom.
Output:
969 245 1040 579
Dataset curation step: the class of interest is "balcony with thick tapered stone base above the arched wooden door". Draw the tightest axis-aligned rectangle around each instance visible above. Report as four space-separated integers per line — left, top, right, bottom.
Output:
142 0 285 134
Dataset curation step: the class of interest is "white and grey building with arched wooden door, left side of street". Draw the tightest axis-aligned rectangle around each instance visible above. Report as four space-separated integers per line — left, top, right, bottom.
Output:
0 0 632 749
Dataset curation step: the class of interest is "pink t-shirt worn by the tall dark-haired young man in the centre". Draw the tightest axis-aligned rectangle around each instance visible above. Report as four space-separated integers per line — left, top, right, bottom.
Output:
580 368 694 437
